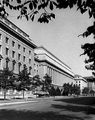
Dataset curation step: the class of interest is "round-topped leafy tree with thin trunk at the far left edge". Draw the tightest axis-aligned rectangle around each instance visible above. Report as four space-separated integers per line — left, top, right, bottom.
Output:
0 68 14 100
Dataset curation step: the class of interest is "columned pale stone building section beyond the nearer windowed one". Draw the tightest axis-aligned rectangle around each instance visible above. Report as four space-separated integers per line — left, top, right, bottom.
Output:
34 46 75 86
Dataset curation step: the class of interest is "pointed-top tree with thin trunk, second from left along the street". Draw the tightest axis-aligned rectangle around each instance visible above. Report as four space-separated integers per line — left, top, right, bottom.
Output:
17 65 31 98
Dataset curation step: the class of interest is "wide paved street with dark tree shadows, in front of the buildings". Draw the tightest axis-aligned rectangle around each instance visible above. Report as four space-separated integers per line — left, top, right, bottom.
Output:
0 97 95 120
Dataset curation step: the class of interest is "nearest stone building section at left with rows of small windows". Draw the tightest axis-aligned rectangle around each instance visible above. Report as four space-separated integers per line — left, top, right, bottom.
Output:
0 17 36 76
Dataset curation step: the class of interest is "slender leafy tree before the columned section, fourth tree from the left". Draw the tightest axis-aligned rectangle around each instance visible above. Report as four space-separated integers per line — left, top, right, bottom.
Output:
42 74 52 92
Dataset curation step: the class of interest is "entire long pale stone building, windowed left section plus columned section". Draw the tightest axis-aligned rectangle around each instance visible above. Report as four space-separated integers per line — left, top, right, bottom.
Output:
0 17 74 86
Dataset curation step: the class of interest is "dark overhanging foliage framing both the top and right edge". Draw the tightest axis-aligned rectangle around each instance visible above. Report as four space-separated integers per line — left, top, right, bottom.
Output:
0 0 95 75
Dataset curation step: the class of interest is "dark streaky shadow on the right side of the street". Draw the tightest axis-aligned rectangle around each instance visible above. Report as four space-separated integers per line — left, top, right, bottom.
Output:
52 97 95 115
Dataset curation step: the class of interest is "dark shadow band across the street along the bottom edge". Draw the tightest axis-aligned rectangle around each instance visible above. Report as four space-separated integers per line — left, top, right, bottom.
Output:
0 109 83 120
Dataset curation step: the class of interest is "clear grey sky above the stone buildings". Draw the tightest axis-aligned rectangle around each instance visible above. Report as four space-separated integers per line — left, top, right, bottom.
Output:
8 5 94 76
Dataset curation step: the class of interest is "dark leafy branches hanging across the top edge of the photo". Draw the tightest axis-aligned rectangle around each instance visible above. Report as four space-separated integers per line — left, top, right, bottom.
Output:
0 0 95 23
